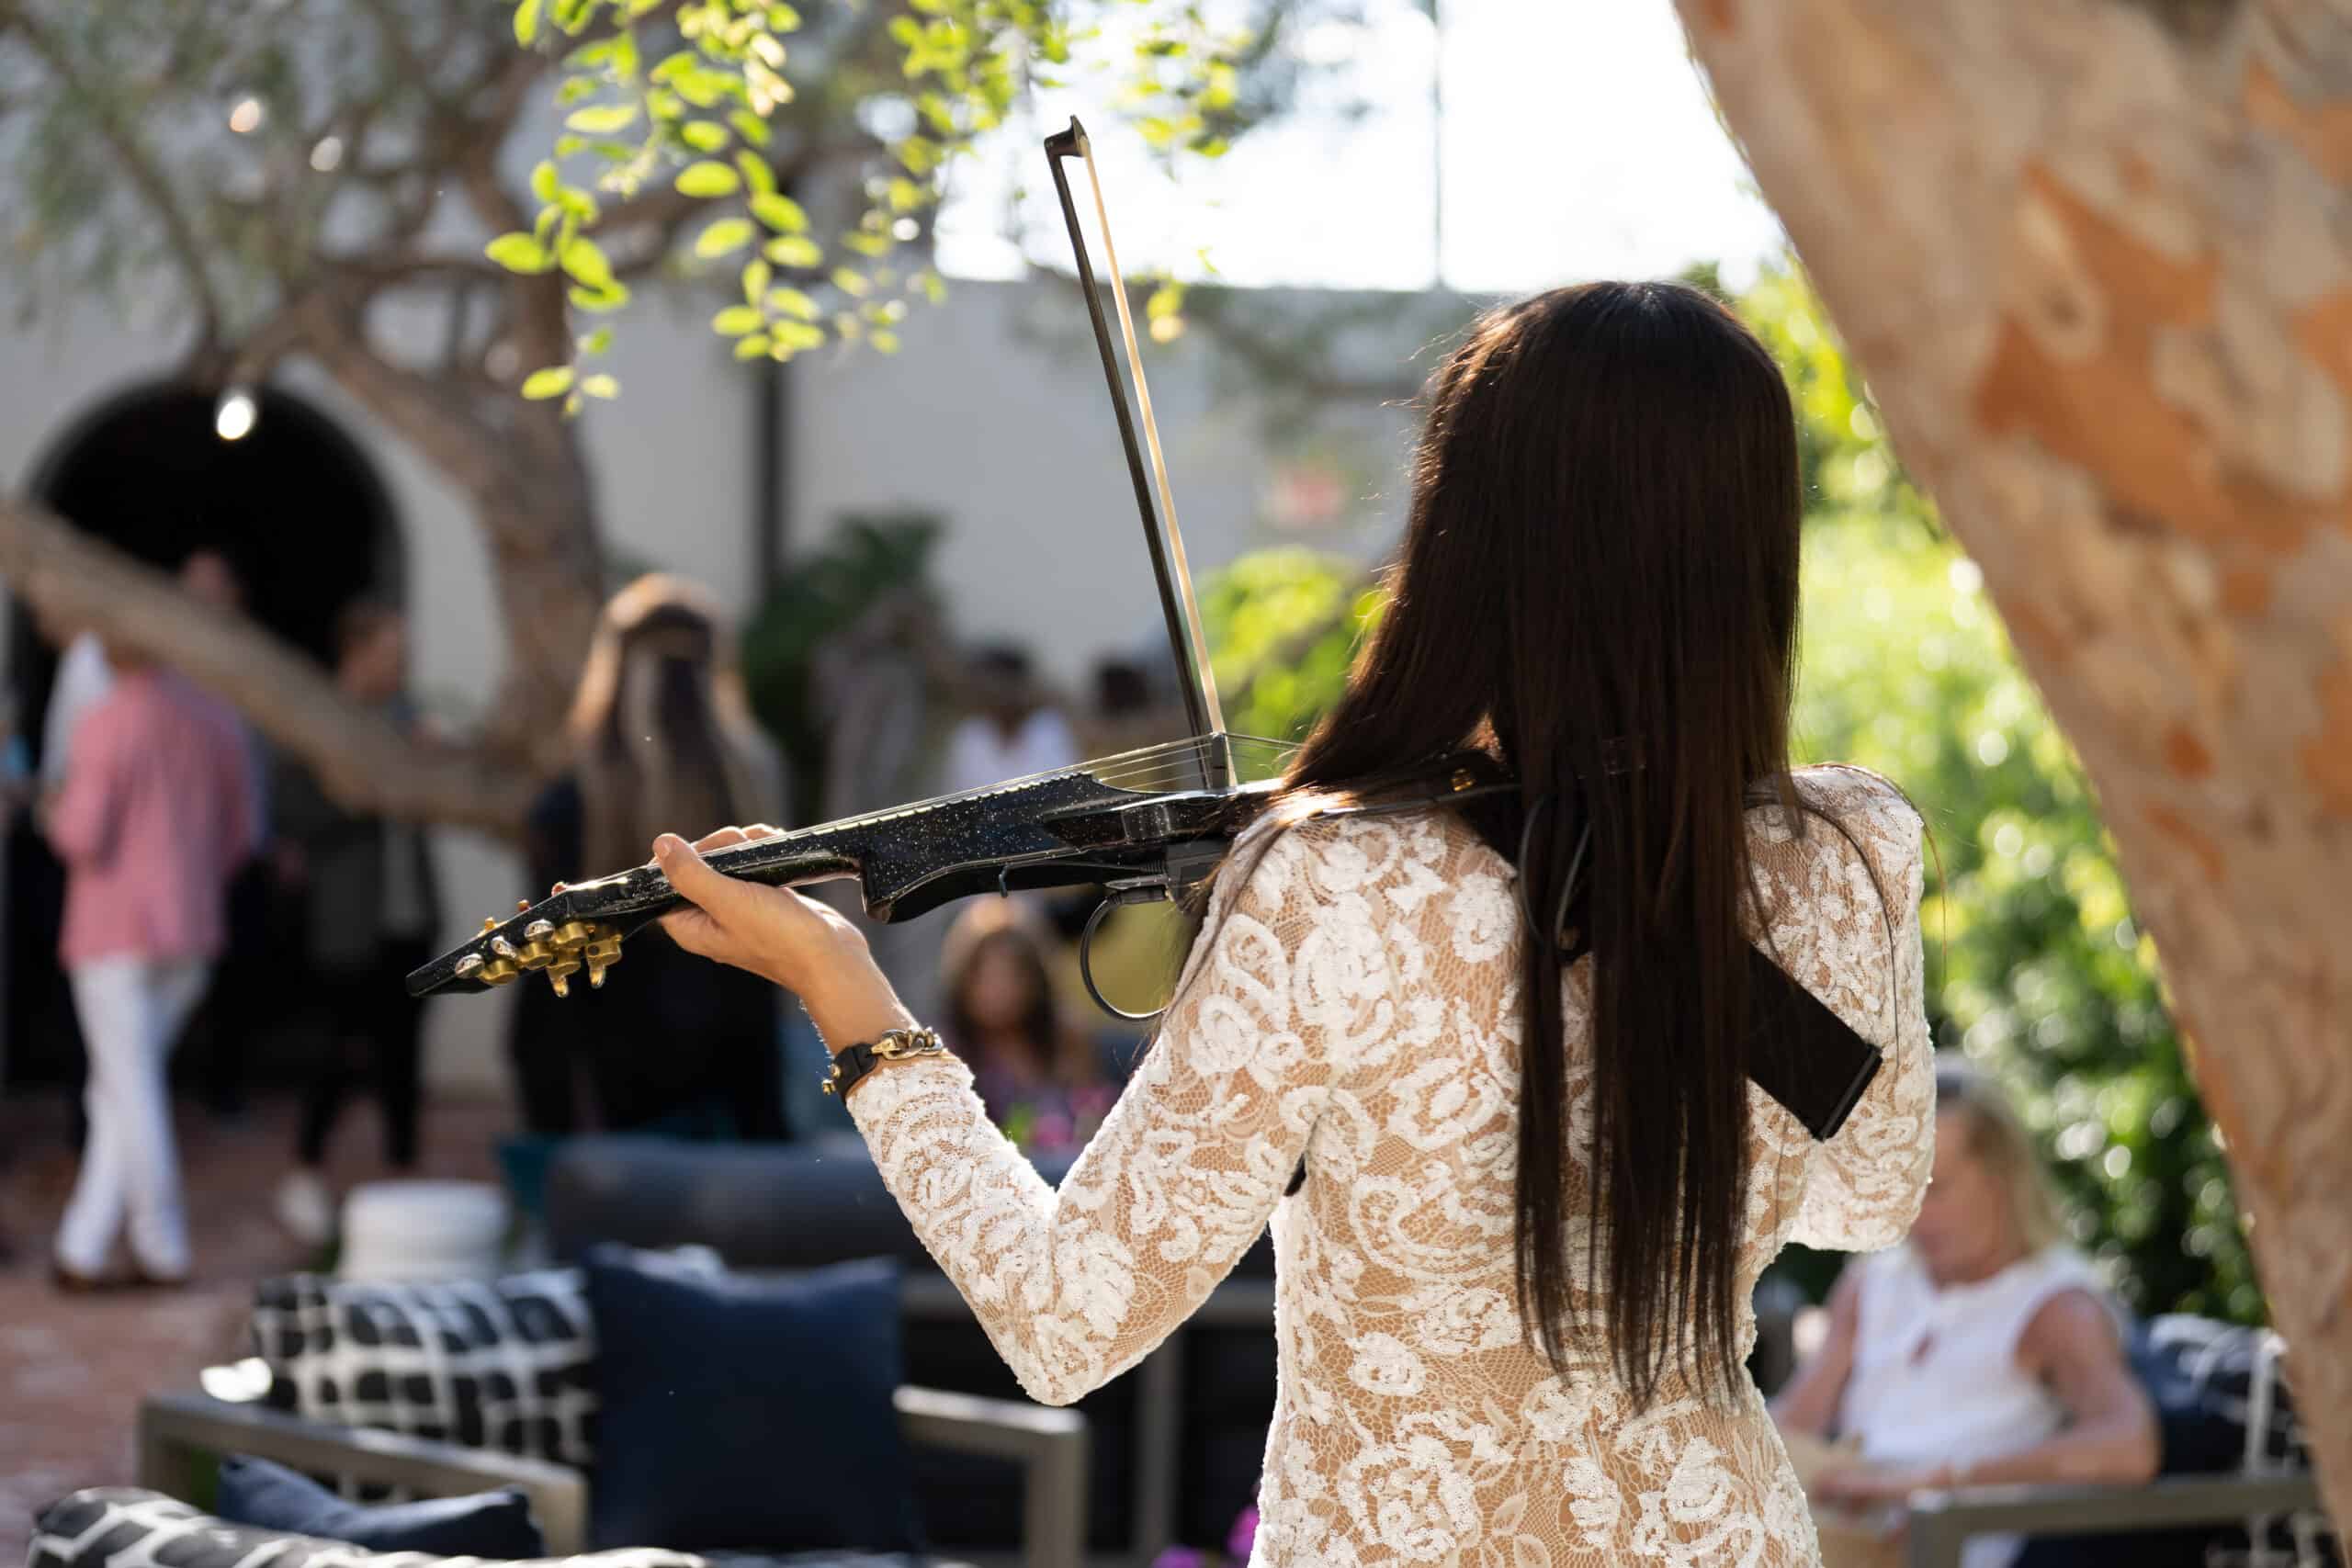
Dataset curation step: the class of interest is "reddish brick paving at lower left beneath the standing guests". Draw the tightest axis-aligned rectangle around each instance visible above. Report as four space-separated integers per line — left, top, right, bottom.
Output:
0 1090 511 1565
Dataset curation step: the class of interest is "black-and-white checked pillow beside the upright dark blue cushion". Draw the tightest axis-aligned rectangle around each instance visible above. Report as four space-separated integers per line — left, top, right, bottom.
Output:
254 1269 595 1470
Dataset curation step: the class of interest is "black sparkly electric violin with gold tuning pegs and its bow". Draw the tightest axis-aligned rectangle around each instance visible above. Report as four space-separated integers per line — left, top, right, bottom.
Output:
407 120 1879 1138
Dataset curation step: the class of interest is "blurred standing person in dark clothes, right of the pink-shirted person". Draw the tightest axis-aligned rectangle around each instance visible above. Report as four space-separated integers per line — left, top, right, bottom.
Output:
276 600 442 1246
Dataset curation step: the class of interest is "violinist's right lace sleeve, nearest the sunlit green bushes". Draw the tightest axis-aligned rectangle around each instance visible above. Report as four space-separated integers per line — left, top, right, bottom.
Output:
1767 769 1936 1253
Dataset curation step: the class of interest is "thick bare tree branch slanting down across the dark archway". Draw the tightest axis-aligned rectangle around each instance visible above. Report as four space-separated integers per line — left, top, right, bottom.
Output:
0 499 532 837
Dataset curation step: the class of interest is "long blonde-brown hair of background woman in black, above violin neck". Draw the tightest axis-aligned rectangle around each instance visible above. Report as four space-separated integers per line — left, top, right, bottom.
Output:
570 571 786 874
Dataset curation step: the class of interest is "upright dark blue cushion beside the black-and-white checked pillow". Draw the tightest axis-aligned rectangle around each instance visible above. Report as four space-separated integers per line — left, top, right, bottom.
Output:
585 1246 920 1551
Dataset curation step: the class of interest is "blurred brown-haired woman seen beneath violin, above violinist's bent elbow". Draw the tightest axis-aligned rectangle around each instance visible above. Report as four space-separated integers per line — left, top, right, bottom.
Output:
941 898 1117 1155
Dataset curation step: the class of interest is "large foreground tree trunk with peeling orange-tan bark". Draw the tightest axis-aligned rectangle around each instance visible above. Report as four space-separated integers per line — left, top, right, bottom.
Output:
1677 0 2352 1521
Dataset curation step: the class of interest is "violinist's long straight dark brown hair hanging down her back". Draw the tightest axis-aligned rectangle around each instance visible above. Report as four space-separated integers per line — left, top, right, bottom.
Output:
1277 282 1802 1404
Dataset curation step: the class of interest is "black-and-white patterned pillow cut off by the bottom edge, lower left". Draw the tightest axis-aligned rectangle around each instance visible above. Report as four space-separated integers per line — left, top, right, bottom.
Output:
26 1485 948 1568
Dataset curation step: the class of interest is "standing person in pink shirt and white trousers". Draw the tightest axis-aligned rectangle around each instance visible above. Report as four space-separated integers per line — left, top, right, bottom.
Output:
47 644 256 1288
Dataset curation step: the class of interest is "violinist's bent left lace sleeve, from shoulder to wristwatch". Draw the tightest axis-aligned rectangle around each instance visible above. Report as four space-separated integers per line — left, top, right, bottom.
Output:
849 825 1393 1404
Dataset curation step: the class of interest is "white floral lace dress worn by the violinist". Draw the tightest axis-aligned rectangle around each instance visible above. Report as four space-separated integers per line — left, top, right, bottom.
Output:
849 769 1933 1568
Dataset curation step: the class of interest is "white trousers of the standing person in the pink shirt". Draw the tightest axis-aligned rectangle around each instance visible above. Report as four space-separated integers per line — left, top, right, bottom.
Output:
56 957 211 1277
